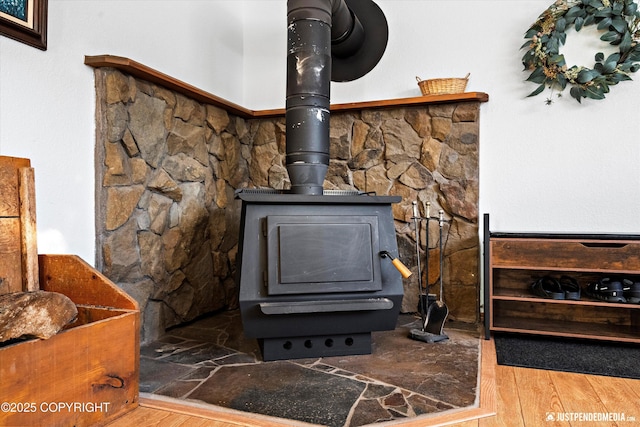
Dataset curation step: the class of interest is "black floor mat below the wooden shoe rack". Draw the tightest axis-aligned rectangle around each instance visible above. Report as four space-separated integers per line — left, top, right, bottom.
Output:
494 334 640 379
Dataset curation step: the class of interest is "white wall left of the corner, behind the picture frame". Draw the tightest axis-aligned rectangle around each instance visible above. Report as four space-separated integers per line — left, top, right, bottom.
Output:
0 0 243 264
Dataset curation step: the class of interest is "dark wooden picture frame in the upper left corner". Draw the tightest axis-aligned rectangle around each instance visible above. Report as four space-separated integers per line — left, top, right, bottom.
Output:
0 0 48 50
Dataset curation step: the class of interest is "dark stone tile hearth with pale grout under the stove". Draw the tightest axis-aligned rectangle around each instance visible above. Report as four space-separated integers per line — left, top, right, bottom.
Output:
140 311 480 427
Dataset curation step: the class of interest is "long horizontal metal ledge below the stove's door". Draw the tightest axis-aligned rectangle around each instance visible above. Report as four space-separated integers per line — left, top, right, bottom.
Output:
259 298 393 315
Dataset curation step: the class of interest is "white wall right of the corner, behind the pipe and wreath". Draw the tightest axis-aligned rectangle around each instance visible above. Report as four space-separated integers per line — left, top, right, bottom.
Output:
244 0 640 233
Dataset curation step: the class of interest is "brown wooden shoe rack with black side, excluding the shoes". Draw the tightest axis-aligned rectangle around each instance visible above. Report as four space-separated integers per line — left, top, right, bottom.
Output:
484 214 640 343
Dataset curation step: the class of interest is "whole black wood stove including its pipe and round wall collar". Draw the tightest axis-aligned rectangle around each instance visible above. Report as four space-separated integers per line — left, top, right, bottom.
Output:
237 0 403 360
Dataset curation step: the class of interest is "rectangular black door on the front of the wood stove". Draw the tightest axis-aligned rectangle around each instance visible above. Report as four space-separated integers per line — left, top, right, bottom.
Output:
266 215 382 295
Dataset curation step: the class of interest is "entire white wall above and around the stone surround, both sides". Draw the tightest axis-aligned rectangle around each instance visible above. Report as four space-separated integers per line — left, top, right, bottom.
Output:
0 0 640 263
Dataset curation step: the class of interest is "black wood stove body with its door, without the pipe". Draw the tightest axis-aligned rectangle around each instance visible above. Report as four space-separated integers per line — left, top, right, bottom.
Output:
238 190 403 360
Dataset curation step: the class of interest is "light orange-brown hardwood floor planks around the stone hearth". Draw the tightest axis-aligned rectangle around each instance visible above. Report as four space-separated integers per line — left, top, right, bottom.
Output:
108 340 640 427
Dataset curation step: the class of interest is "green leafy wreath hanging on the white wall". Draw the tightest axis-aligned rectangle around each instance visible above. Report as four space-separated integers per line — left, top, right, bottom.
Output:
521 0 640 104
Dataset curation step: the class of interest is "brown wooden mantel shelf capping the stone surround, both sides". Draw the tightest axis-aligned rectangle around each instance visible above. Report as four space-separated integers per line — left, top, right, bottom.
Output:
84 55 489 119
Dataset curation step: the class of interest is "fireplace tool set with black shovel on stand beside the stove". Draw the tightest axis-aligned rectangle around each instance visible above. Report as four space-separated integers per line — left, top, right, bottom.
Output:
409 205 449 343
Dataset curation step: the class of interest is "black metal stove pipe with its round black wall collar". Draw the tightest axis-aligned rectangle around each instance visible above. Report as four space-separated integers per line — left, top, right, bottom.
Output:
285 0 388 195
